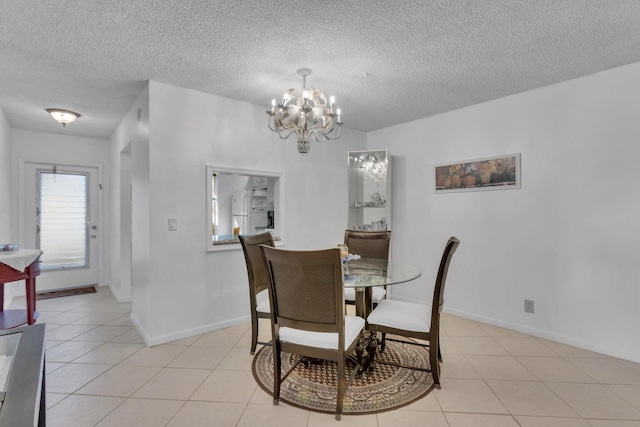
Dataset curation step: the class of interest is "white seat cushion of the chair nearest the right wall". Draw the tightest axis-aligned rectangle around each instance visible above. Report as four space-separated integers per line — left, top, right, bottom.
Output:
367 299 431 332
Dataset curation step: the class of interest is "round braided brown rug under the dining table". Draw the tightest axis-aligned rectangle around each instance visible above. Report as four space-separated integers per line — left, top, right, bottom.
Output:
252 341 433 415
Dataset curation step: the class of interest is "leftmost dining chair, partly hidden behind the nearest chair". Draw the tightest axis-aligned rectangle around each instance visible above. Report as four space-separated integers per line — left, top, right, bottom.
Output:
238 232 275 354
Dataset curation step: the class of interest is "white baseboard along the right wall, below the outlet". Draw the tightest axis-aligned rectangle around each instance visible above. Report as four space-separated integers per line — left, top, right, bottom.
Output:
443 308 640 363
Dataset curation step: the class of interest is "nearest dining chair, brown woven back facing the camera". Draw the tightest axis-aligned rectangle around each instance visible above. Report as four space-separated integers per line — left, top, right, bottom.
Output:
262 245 364 420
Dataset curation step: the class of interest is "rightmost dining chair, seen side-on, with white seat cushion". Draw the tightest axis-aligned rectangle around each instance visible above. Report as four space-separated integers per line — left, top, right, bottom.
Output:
367 237 460 388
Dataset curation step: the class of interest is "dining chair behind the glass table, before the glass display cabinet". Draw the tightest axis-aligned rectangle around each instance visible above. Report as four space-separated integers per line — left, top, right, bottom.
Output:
344 230 391 307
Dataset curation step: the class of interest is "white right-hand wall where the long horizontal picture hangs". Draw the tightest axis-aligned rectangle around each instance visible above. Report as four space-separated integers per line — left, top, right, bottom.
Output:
367 64 640 362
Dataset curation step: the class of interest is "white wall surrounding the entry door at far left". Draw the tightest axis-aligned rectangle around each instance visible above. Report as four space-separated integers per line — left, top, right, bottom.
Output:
10 129 111 293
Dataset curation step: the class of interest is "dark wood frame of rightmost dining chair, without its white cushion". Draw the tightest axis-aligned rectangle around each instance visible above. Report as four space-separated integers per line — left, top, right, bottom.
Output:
369 236 460 389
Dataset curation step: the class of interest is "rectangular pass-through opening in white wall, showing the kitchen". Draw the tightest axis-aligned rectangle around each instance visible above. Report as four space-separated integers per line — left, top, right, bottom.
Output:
206 166 284 250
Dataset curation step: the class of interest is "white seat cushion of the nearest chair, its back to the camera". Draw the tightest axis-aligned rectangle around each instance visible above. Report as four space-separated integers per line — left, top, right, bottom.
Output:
280 316 364 350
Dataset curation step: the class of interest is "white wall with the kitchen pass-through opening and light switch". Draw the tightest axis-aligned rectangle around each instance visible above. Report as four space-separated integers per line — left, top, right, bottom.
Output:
112 81 365 345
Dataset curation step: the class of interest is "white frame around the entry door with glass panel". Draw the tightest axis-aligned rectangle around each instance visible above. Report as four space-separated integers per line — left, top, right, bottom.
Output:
14 157 109 295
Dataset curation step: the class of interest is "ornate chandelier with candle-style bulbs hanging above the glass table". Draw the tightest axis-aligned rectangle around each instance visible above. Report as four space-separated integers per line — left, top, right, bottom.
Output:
267 68 342 154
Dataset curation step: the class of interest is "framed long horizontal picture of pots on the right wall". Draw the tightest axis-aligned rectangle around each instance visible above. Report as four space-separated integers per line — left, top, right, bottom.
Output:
434 153 520 194
